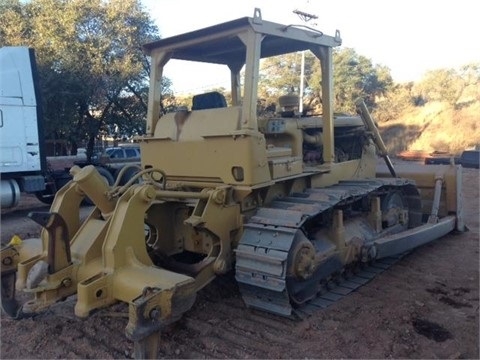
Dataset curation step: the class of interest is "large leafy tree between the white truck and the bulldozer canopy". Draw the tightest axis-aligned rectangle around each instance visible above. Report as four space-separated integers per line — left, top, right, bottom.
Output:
0 0 162 155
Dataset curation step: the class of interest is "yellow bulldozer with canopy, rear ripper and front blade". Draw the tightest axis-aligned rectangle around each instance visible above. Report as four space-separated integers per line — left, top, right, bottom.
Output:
1 9 465 358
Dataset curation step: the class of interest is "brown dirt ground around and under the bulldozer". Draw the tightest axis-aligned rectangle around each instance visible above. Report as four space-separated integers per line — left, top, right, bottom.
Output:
0 165 479 359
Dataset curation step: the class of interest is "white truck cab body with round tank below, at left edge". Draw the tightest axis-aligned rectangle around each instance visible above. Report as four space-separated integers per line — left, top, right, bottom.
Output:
0 46 46 207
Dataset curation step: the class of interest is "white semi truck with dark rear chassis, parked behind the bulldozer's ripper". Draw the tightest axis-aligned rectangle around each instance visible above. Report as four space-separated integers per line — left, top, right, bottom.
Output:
0 46 140 208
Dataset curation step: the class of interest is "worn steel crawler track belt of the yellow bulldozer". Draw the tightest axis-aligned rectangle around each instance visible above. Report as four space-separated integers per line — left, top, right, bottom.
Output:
235 178 421 317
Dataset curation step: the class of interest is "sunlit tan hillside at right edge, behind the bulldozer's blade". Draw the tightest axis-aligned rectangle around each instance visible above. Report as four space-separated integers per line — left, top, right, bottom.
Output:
378 101 480 154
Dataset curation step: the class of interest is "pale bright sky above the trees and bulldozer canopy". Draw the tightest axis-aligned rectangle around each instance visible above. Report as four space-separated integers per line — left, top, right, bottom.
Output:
142 0 480 92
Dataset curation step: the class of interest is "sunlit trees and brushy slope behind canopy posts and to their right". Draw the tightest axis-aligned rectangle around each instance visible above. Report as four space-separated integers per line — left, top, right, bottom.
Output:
255 44 480 153
